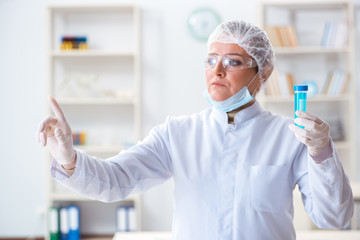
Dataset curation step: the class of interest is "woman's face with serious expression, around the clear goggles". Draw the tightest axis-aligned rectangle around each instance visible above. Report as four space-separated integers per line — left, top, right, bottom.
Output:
205 42 260 101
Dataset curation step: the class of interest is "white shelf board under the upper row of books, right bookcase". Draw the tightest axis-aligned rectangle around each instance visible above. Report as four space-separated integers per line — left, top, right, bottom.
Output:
274 46 350 55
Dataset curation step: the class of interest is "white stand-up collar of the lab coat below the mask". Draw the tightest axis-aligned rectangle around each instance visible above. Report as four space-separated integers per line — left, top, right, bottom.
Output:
211 101 264 127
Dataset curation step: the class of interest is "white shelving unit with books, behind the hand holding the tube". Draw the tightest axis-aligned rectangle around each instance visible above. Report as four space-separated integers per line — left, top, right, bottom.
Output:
258 0 359 230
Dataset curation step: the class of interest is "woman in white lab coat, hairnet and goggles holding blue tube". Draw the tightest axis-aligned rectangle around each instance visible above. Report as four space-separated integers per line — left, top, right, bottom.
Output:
38 21 354 240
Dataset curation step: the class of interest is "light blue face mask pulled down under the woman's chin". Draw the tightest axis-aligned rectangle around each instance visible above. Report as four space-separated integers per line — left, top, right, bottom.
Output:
204 73 257 112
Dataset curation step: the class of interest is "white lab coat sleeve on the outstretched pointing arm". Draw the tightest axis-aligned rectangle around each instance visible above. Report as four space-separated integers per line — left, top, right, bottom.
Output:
51 121 172 202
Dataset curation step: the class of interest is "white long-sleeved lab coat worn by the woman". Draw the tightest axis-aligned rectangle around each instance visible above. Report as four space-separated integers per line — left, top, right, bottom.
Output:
51 102 354 240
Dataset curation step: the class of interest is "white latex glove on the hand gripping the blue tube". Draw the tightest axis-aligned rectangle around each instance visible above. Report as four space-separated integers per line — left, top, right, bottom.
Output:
289 111 330 157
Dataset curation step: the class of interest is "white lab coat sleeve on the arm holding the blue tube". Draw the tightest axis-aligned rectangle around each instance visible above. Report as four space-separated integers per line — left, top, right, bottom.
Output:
298 141 354 228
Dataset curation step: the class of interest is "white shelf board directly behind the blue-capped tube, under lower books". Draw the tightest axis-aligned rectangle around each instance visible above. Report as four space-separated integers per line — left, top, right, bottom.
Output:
261 94 350 103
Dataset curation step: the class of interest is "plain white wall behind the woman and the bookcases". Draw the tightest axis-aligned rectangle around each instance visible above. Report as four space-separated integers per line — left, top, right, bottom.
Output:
0 0 359 237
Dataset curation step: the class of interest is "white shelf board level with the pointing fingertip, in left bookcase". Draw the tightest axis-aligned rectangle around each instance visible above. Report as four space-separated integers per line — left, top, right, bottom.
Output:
57 98 135 105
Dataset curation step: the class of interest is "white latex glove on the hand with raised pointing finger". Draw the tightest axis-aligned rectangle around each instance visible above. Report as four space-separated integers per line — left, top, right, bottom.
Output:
37 97 76 165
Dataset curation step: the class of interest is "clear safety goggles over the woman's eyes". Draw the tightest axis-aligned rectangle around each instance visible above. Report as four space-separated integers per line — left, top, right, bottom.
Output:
205 54 257 71
